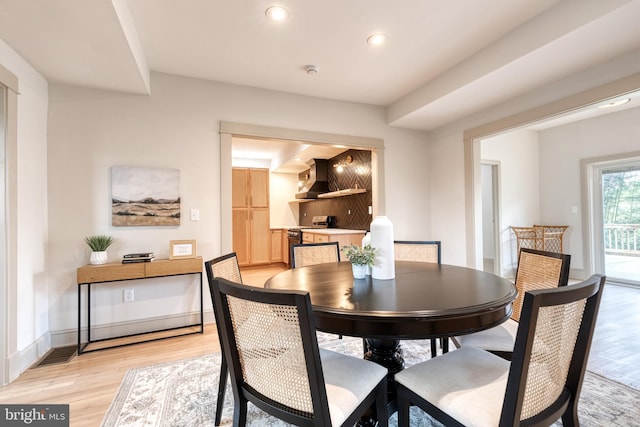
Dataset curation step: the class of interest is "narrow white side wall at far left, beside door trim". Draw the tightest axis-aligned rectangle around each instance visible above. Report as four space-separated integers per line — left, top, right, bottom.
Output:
0 40 50 377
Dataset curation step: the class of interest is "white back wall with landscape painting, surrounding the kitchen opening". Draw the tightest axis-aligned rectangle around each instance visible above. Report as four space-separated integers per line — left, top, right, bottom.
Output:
49 73 430 340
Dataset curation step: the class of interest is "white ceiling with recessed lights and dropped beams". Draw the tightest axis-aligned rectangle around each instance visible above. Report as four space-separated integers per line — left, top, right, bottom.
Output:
0 0 640 171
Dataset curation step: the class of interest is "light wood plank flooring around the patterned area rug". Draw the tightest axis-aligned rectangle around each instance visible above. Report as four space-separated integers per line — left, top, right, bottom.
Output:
0 267 640 427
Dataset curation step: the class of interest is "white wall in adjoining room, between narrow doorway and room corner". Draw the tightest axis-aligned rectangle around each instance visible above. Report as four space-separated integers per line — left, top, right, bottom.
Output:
481 130 541 277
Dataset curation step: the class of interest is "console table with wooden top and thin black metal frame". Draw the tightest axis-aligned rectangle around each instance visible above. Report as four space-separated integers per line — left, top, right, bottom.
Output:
77 257 204 354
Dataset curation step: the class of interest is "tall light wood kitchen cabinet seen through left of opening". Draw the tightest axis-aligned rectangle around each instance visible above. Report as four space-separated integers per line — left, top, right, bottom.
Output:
231 168 272 266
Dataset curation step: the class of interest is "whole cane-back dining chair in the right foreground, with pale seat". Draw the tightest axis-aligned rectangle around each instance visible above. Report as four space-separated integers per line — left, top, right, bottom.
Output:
395 275 605 427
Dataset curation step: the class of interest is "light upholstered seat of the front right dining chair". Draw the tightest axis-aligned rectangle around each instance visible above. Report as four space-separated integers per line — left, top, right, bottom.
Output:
395 347 511 426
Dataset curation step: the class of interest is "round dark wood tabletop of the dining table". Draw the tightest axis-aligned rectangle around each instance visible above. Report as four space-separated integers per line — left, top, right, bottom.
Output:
265 262 516 339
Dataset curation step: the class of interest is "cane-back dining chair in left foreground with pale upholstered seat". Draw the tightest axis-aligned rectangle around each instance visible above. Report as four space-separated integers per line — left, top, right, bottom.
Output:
210 278 387 427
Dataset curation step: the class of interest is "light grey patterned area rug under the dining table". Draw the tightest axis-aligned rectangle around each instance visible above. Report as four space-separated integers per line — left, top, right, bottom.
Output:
102 333 640 427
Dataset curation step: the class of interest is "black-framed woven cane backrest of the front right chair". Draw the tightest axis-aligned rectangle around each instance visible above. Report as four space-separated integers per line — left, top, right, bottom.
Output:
500 275 605 425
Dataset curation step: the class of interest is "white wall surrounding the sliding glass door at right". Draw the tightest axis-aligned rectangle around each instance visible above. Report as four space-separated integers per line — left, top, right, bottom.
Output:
540 108 640 277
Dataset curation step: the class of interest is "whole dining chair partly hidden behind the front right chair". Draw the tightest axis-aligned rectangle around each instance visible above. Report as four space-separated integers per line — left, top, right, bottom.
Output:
452 248 571 360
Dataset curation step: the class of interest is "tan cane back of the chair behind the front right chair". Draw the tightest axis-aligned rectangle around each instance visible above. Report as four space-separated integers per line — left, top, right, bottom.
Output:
511 248 571 322
